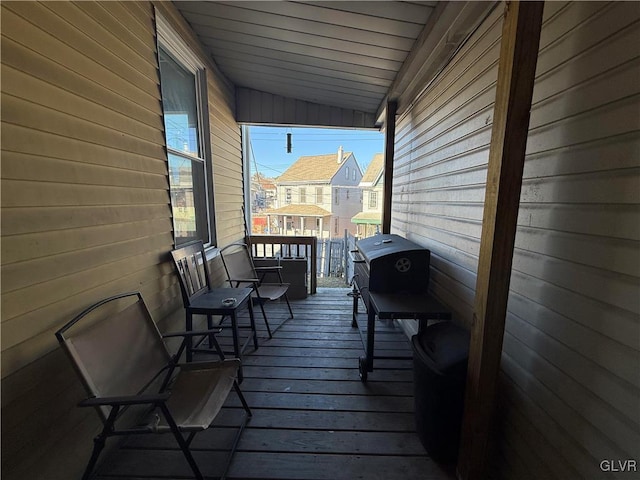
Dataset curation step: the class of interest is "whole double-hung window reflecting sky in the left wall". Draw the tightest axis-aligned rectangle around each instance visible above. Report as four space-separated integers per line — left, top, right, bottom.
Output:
158 18 214 246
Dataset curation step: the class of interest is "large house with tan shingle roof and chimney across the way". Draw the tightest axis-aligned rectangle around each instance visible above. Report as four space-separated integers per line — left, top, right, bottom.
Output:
266 147 362 238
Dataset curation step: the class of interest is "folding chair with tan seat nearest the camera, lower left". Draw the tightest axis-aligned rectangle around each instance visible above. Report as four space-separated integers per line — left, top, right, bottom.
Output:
56 292 251 479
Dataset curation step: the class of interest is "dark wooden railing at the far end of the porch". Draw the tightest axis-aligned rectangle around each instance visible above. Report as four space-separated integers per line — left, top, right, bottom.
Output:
247 235 318 294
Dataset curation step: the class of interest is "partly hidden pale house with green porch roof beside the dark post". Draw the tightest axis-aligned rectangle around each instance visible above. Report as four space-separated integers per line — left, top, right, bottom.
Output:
351 153 384 238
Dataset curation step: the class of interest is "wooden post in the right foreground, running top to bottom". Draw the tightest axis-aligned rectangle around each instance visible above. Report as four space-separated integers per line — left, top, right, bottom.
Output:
457 1 544 480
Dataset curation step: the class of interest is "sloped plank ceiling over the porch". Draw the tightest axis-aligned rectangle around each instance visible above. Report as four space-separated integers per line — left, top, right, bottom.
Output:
175 1 437 114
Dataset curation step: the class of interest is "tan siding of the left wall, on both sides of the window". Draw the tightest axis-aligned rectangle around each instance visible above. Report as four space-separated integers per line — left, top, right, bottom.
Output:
1 2 244 480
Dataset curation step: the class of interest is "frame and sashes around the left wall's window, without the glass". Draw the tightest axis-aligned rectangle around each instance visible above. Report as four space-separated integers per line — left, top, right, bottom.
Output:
156 12 216 247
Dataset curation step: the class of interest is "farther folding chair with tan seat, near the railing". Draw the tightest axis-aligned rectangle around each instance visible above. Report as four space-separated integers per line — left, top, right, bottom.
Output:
220 243 293 338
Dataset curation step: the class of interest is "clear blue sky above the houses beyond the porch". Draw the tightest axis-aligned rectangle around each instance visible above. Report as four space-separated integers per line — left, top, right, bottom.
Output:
249 126 384 177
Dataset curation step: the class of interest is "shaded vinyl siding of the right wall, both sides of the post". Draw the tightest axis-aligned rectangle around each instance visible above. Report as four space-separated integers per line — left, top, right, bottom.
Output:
392 2 640 479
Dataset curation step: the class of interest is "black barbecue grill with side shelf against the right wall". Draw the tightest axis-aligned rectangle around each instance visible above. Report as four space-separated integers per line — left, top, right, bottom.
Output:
351 234 450 381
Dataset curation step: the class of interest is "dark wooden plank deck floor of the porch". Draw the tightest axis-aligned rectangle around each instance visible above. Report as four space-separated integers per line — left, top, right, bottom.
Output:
97 289 455 480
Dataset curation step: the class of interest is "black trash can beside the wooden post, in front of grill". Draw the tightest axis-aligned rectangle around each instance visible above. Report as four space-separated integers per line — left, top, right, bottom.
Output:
411 322 470 463
